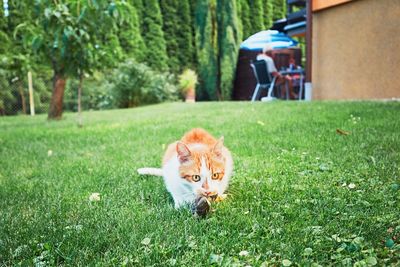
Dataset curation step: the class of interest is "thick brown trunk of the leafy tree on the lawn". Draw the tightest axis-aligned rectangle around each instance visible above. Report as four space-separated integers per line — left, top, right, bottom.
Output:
47 73 67 120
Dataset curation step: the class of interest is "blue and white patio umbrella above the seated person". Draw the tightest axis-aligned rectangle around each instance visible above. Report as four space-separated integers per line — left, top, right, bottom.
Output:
240 30 298 51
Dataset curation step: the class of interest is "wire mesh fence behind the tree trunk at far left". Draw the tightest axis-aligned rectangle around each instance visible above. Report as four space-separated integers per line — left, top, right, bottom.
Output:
0 73 91 116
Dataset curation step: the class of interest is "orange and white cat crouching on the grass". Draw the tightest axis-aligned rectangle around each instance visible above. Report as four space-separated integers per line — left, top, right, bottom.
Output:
138 129 233 209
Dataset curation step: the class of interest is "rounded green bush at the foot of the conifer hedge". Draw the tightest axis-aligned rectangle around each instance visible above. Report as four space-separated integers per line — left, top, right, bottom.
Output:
111 60 178 108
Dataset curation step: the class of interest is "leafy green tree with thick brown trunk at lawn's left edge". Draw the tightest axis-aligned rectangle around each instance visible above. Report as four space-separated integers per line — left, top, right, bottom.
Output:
20 0 129 119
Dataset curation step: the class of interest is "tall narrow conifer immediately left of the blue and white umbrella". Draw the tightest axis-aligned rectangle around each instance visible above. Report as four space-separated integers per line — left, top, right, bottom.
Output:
217 0 240 100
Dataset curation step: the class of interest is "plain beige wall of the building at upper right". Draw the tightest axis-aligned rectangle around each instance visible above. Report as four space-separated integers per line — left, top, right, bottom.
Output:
312 0 400 99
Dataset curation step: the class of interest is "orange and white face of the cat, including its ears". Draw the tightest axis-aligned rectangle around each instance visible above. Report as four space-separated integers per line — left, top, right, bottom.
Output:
177 139 225 196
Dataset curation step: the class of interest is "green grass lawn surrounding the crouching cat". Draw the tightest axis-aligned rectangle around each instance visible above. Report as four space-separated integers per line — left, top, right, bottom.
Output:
0 102 400 266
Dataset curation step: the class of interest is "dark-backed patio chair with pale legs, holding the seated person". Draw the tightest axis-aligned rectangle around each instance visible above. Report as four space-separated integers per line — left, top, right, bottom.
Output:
250 60 276 102
